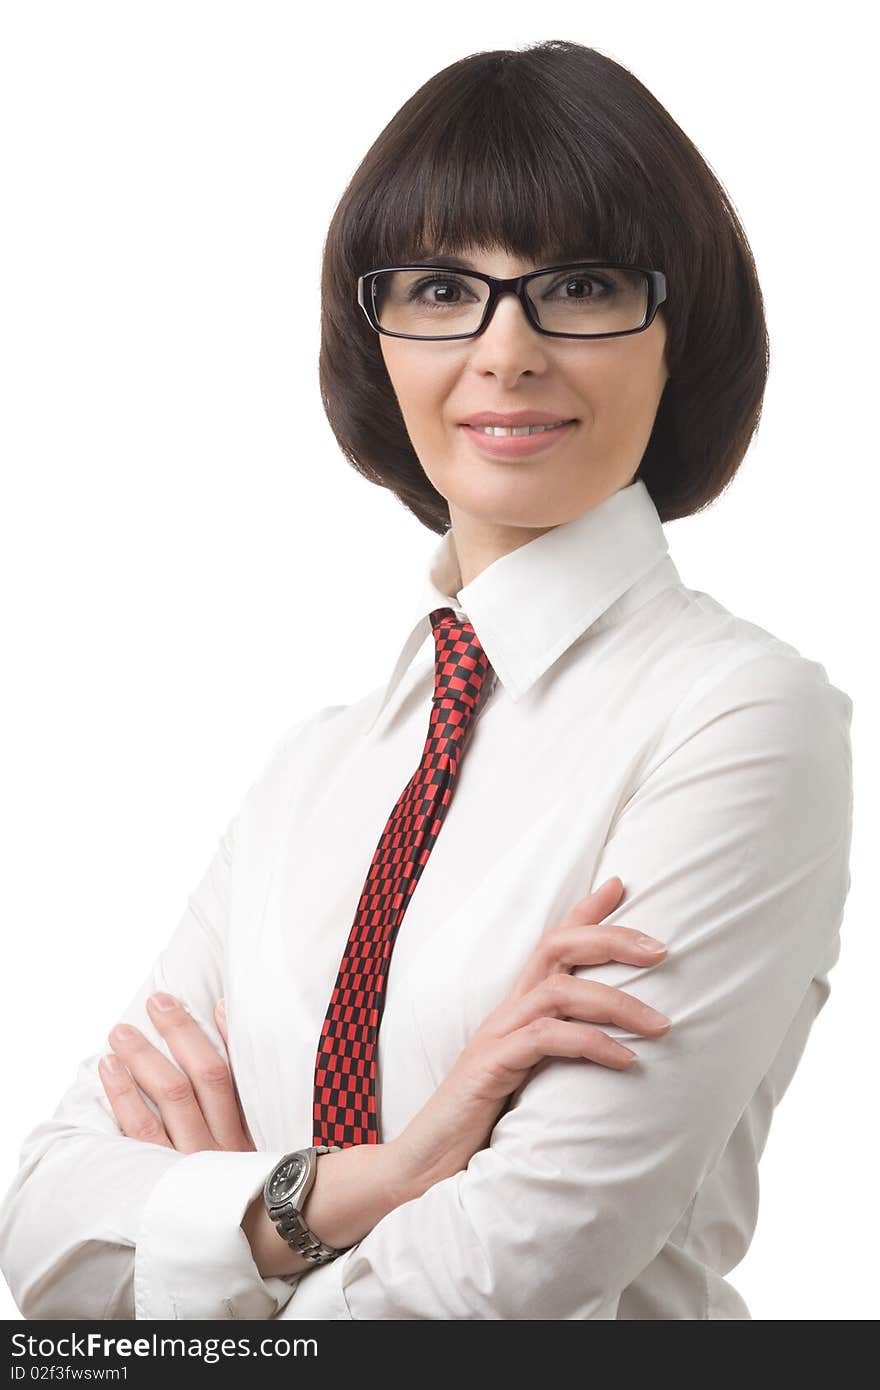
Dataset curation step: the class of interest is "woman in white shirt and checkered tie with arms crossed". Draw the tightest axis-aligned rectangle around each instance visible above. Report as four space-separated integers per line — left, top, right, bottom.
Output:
0 42 852 1319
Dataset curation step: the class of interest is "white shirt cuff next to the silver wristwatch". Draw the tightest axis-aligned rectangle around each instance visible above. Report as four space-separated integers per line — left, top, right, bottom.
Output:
135 1150 302 1321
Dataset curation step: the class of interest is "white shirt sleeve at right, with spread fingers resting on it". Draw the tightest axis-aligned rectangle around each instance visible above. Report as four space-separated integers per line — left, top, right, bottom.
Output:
276 653 852 1321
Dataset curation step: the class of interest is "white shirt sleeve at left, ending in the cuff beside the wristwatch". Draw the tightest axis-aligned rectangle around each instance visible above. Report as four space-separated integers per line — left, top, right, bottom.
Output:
0 726 315 1319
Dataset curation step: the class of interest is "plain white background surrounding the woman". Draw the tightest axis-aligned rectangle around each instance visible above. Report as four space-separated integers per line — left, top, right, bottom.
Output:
0 0 880 1319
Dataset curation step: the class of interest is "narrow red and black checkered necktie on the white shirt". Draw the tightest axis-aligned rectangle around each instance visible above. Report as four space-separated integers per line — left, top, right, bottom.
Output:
311 607 489 1148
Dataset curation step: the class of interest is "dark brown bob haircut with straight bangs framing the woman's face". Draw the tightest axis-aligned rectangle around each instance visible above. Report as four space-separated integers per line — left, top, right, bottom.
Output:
318 39 770 535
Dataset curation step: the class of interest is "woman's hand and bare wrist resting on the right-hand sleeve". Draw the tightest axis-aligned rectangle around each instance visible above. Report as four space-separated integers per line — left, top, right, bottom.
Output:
393 877 670 1191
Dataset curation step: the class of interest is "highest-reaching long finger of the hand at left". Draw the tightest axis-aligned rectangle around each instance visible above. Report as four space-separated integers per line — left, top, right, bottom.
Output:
147 992 251 1150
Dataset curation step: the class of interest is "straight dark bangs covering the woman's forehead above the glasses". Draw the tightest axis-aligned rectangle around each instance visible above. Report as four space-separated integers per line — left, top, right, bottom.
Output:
359 54 662 274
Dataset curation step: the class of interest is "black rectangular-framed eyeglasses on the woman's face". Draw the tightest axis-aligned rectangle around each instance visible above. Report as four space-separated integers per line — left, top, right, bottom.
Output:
357 261 666 341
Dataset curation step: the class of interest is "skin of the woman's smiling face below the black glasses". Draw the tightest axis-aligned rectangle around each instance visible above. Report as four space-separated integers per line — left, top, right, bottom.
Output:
380 249 669 582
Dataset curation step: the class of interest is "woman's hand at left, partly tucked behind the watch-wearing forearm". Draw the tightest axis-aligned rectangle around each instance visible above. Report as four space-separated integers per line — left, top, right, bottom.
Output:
99 994 256 1154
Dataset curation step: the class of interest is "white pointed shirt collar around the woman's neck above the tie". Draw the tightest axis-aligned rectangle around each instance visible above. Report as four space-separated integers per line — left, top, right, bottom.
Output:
367 478 680 733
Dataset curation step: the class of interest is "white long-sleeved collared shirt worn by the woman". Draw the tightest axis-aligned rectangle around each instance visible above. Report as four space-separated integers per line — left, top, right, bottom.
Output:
0 481 852 1319
